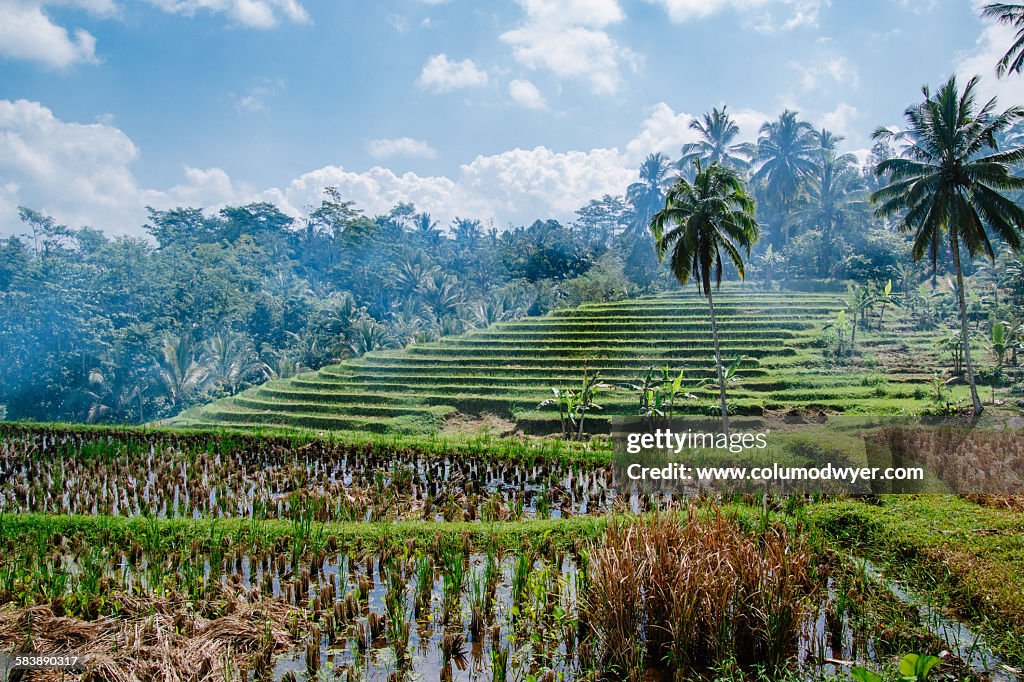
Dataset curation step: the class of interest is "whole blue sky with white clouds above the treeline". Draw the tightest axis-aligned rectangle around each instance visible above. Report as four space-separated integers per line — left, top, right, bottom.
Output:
0 0 1024 236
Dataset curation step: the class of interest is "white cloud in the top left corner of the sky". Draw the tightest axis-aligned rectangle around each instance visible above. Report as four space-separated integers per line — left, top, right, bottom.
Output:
0 0 117 69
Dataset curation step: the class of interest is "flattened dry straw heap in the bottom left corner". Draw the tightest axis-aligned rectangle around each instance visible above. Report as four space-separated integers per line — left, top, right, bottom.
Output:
0 591 296 682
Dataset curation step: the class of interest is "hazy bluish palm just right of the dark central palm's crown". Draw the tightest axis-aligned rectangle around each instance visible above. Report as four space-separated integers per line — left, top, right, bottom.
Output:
754 110 820 242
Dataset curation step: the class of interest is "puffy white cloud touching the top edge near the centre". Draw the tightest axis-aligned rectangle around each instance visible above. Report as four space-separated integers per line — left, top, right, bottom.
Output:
501 0 639 94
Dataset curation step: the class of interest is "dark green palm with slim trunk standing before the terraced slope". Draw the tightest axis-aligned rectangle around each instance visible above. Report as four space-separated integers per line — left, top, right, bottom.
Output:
650 161 760 432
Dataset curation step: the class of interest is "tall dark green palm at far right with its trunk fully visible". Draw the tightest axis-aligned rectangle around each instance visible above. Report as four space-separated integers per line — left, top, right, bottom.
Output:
871 76 1024 416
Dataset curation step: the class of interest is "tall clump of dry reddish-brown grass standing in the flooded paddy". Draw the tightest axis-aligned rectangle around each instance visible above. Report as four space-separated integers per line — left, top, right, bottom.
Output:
583 511 815 678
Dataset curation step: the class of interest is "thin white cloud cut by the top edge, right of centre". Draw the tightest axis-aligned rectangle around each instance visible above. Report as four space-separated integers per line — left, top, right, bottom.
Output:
648 0 831 31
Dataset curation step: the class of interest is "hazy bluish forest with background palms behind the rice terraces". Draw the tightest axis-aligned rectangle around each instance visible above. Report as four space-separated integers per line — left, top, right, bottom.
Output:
6 106 1024 423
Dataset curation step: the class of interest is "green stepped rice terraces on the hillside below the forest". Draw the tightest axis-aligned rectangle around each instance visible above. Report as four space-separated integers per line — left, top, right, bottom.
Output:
177 288 950 432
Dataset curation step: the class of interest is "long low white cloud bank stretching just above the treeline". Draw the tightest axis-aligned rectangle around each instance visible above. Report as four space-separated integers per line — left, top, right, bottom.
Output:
0 100 765 235
